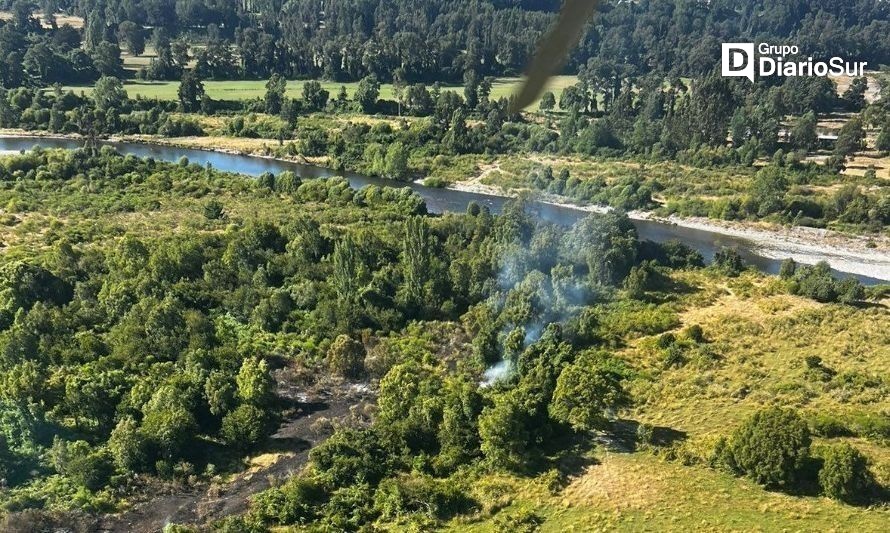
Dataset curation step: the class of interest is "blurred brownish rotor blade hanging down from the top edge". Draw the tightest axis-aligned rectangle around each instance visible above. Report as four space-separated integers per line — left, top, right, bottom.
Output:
510 0 596 112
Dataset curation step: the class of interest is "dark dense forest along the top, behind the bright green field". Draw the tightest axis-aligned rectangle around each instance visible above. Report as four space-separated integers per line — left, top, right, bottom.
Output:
0 0 890 87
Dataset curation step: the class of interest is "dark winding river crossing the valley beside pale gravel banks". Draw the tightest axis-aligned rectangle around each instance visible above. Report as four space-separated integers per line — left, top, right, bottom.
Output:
0 136 890 285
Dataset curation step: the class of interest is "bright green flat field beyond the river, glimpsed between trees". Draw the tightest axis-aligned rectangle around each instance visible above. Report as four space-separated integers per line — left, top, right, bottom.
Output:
66 74 577 108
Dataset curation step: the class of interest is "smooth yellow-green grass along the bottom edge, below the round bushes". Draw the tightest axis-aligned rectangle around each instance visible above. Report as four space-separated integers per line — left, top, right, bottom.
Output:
445 453 890 533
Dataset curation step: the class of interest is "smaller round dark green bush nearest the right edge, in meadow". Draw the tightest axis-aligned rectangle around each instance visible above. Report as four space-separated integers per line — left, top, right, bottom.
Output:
819 443 874 503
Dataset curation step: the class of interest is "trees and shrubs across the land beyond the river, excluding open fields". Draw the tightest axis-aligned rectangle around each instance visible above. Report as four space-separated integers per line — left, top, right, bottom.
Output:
0 1 890 239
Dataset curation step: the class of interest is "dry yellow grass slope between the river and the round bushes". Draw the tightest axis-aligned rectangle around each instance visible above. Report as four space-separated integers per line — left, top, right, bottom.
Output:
623 274 890 437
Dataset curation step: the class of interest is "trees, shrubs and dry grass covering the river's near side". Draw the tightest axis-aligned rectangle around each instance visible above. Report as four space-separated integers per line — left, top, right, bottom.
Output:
0 149 888 531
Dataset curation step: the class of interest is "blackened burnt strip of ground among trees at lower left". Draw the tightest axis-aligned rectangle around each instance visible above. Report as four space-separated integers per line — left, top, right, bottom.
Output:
96 372 373 533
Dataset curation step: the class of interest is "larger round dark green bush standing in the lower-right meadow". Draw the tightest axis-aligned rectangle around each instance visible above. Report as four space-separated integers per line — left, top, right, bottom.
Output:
729 408 810 487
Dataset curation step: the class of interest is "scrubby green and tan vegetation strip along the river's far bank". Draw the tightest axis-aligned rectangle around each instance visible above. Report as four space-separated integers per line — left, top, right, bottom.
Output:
0 67 890 238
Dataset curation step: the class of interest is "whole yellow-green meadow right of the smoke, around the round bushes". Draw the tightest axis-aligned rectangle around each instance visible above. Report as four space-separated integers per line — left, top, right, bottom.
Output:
438 271 890 532
